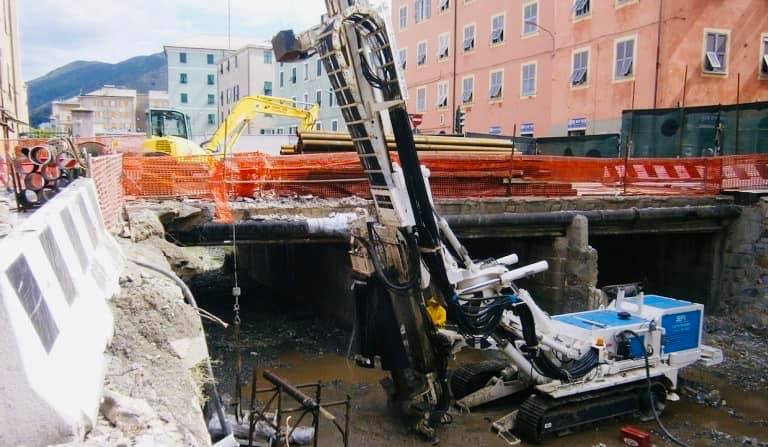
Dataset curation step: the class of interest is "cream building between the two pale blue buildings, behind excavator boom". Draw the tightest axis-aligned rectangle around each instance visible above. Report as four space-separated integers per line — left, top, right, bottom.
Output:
218 42 275 135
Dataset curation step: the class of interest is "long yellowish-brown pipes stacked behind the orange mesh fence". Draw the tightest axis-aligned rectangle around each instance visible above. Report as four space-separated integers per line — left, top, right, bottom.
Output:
295 132 515 154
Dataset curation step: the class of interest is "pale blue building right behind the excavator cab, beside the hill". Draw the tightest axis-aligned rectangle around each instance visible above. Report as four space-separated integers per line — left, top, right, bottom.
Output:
164 41 231 141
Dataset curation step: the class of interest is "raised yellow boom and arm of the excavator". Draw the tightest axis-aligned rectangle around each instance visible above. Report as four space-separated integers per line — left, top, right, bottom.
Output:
204 95 320 153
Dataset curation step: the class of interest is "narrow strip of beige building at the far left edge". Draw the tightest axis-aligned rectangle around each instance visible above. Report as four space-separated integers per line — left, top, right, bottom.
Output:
0 0 29 138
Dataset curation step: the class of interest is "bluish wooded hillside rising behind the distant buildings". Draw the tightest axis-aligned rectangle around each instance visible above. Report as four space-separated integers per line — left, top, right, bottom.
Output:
28 53 168 126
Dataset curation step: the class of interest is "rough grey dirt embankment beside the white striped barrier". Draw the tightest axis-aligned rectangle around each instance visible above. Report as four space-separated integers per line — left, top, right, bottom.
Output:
53 211 222 446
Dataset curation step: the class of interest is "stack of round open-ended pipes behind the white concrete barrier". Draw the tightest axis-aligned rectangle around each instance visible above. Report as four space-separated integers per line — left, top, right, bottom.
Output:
13 146 79 209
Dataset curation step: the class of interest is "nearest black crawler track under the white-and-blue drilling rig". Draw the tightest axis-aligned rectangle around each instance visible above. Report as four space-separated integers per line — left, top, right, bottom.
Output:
515 380 661 443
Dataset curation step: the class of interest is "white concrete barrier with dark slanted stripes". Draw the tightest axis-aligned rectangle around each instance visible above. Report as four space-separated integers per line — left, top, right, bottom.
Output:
0 179 124 446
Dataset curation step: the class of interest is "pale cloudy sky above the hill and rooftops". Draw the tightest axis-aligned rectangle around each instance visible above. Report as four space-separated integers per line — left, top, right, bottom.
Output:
17 0 340 80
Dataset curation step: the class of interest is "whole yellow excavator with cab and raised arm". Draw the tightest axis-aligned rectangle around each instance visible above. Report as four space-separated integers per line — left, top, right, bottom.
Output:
143 95 320 157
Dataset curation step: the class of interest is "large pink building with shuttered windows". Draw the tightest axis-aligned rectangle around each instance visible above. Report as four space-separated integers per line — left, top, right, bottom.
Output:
392 0 768 136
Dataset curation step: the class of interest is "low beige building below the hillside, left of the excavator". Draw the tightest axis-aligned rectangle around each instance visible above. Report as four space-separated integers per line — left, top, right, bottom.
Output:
51 85 137 135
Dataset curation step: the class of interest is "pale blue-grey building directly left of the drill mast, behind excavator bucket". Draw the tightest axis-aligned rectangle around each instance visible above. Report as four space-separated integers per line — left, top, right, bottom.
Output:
272 55 346 134
